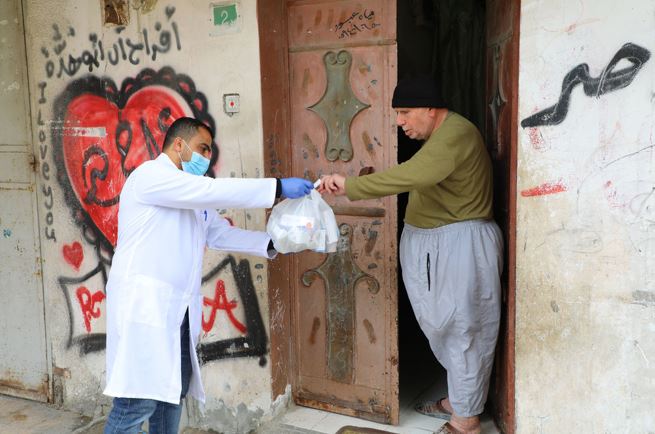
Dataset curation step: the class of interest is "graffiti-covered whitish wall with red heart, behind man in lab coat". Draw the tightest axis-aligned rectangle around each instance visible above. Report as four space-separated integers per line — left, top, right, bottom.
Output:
18 0 284 432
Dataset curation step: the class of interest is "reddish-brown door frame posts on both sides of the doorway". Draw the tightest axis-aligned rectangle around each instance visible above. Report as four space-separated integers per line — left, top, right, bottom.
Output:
257 0 520 433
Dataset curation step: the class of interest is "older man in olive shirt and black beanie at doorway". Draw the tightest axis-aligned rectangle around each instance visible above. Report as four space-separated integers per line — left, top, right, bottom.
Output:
319 78 502 433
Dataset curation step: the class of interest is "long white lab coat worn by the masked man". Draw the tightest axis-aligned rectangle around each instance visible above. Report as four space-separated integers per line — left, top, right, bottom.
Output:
104 154 276 404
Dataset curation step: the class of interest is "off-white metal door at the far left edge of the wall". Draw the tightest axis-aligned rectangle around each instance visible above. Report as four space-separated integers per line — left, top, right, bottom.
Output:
0 0 48 401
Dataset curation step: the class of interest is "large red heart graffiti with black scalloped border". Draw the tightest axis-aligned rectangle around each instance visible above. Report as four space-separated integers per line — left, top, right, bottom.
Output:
52 68 218 249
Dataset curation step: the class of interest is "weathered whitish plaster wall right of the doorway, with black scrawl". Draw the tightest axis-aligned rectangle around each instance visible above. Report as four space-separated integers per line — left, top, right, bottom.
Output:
516 0 655 433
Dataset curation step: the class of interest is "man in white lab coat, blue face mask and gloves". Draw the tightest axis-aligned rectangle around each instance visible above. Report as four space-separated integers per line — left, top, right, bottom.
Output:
104 118 313 434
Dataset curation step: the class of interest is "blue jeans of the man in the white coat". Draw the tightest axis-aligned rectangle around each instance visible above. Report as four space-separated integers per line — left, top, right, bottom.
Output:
105 311 192 434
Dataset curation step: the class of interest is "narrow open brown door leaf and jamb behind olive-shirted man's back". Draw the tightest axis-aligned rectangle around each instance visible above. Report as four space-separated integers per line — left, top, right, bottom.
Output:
486 0 520 433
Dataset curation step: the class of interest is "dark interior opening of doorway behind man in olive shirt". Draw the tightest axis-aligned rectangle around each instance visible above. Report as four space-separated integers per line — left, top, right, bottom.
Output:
397 0 507 428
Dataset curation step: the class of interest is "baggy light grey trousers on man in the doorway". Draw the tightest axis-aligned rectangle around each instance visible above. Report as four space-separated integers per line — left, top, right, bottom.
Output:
400 220 503 417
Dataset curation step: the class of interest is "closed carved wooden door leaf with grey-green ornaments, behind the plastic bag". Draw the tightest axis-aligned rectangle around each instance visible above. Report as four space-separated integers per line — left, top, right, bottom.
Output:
287 0 398 423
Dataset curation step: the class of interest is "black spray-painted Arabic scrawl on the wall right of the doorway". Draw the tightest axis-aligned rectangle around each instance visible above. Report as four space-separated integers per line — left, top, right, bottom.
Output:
521 43 650 128
